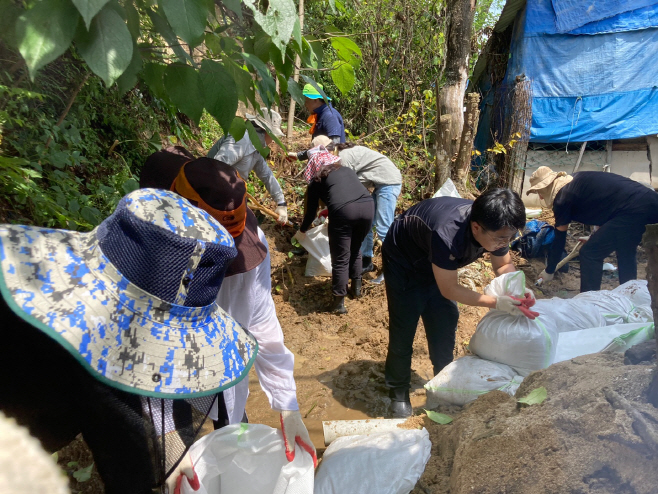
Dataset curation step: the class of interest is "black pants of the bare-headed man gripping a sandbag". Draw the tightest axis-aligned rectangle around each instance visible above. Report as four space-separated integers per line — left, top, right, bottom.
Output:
382 247 459 390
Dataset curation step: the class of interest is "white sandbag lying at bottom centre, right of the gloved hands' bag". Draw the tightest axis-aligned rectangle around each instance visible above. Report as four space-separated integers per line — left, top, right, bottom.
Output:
315 429 432 494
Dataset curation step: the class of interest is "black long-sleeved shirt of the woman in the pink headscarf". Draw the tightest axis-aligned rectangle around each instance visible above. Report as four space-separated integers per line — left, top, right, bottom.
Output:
300 166 372 231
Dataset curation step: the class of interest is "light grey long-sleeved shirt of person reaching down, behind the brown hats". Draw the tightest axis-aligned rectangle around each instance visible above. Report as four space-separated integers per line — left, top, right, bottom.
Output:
208 132 286 204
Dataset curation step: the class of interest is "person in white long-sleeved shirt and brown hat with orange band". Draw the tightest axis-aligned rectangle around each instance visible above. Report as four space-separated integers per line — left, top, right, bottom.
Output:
140 150 317 490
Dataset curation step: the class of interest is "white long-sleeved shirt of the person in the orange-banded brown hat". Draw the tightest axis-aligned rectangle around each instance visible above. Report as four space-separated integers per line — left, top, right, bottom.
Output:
217 228 299 424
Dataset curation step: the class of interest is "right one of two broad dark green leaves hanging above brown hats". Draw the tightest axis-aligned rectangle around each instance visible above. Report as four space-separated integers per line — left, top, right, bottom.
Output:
199 59 238 134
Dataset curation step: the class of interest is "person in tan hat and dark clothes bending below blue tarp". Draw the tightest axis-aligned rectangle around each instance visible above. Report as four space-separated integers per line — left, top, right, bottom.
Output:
526 166 658 292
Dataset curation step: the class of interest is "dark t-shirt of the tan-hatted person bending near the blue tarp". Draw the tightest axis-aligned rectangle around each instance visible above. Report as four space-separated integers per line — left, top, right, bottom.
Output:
553 172 658 226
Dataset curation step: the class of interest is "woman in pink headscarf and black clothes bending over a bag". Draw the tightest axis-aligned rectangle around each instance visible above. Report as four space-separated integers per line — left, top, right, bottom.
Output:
299 146 374 314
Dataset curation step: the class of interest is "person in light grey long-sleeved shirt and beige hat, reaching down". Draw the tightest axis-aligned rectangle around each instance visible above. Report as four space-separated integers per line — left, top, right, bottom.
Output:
207 108 288 225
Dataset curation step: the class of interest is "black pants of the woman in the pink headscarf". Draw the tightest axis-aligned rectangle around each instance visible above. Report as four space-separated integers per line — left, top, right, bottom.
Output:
329 199 375 296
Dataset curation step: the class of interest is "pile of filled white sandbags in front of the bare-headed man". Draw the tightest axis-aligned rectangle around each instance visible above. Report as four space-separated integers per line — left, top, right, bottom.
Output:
425 271 655 406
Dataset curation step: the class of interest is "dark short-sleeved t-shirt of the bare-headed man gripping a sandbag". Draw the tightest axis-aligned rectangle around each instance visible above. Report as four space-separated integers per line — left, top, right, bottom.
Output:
384 197 509 276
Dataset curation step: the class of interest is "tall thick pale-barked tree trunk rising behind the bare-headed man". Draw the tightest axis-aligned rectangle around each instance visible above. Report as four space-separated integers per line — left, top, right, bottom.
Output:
434 0 475 187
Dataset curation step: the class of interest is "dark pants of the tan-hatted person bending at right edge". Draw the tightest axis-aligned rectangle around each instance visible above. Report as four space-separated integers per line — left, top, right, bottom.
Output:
579 208 658 292
